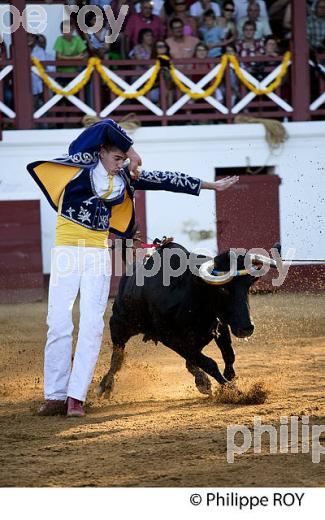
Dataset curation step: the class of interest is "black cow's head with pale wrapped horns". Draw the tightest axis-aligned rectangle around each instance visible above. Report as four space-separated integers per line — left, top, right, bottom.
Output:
199 251 276 338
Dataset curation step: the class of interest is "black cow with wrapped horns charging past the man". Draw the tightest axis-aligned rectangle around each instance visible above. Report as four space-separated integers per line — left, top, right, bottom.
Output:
98 242 272 397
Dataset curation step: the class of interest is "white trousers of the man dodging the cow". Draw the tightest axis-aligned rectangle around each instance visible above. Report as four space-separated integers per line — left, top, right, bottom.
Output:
44 246 111 401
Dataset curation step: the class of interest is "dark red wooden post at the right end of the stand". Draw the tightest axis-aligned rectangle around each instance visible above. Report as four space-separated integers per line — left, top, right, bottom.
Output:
291 0 310 121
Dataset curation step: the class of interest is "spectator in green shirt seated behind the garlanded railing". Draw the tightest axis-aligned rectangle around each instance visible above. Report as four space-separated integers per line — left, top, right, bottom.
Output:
54 21 87 72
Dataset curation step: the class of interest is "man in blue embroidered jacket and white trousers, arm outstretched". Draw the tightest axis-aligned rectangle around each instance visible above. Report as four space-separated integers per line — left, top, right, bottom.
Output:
27 119 238 417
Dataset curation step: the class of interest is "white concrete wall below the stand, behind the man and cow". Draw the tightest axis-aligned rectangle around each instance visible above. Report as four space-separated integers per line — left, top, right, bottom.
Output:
0 122 325 273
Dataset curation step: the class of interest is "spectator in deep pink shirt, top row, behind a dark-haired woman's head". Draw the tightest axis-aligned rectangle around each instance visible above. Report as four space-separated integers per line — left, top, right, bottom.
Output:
125 0 165 49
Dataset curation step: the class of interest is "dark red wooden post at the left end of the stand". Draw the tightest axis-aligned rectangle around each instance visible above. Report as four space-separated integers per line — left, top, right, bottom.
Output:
10 0 33 130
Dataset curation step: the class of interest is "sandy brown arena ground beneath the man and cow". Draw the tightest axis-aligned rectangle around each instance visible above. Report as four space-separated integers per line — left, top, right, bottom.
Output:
0 293 325 487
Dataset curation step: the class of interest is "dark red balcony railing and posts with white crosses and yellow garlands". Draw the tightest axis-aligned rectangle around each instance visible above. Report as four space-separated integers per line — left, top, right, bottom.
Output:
0 0 325 129
